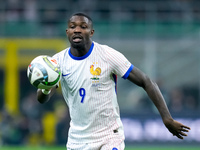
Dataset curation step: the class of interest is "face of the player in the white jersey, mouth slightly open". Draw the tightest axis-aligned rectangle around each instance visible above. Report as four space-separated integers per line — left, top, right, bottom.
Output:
66 16 94 48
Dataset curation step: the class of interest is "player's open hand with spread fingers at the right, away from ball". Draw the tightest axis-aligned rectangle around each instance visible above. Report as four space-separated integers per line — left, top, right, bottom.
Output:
164 119 190 139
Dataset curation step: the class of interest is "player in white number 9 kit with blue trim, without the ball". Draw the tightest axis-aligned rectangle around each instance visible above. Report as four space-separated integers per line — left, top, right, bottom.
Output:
37 13 190 150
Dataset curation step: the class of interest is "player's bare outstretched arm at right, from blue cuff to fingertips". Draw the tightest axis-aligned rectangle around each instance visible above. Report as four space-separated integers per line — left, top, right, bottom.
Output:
128 66 190 139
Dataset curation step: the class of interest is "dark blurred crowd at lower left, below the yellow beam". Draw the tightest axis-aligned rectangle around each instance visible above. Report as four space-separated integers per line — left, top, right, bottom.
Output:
0 70 70 147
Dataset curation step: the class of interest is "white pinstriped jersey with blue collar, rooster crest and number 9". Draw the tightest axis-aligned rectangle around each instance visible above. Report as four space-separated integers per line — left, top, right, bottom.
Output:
53 42 133 143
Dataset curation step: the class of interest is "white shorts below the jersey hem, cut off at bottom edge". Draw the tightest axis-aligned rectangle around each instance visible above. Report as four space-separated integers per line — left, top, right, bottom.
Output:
67 138 125 150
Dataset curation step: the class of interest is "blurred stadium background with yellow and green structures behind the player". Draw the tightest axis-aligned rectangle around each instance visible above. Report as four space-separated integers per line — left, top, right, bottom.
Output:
0 0 200 149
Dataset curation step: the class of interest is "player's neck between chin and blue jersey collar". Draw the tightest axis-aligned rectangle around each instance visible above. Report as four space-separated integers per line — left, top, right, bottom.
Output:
70 41 92 57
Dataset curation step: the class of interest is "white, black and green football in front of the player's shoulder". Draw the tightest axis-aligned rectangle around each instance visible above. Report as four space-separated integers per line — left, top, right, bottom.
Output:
27 55 61 89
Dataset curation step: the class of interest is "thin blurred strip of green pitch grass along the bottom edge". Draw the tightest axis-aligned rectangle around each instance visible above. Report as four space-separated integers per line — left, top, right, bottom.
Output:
0 145 200 150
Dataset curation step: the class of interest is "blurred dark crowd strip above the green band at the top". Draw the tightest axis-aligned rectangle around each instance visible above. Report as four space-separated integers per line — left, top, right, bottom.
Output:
0 0 200 23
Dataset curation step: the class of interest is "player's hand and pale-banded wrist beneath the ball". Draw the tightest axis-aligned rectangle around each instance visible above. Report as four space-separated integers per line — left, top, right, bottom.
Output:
37 86 57 104
